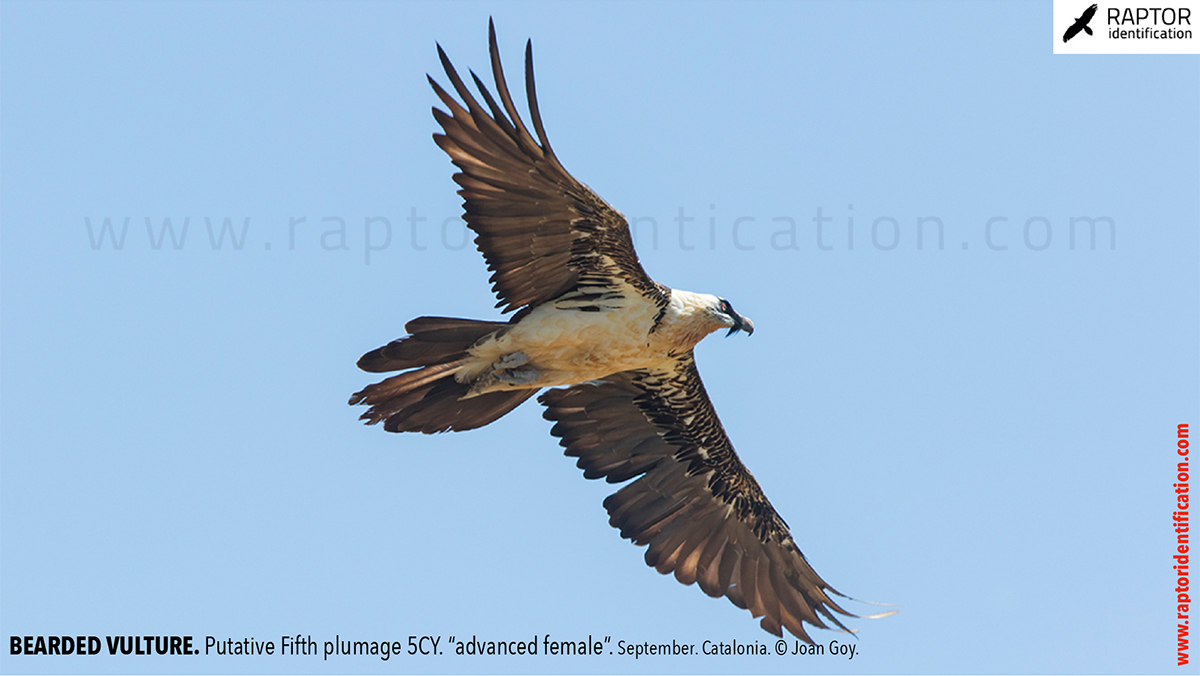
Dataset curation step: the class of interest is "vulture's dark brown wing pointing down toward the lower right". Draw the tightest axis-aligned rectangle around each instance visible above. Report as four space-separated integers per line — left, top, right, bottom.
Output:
539 352 868 642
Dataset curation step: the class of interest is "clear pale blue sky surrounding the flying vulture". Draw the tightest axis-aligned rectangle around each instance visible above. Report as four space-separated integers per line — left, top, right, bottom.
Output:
0 1 1200 672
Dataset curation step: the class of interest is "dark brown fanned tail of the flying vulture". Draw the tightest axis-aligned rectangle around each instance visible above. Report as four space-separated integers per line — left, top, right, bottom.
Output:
350 317 538 435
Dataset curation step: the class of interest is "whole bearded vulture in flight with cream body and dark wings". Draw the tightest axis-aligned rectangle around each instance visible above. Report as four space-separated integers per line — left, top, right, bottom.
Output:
350 22 883 642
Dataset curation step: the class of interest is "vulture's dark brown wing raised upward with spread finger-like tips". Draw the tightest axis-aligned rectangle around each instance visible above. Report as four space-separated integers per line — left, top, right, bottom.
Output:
430 22 667 312
